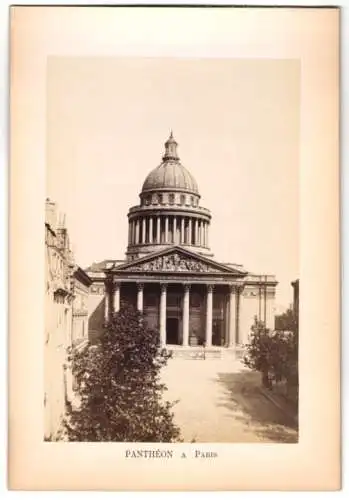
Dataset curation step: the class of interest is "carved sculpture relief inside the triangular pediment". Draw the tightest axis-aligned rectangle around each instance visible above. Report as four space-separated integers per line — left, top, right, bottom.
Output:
130 253 219 273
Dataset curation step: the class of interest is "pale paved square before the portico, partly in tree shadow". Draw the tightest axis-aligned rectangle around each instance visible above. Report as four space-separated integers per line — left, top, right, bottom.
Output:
162 358 297 443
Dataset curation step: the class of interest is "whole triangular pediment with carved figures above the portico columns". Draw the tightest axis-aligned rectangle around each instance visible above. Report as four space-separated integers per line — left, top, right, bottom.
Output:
114 247 246 276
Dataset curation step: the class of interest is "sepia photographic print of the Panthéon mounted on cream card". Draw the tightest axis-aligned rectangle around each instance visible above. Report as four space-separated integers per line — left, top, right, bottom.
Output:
44 57 300 443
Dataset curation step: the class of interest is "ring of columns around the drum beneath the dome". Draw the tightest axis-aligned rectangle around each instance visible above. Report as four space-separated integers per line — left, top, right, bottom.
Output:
128 215 209 248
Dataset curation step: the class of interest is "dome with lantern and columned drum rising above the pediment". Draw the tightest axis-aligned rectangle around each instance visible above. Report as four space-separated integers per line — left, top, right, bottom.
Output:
126 132 212 260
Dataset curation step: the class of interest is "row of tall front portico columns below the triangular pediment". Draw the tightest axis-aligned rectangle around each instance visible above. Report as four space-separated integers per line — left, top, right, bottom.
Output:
105 283 241 347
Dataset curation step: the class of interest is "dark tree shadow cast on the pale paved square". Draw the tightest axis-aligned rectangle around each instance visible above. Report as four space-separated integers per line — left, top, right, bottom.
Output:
216 371 298 443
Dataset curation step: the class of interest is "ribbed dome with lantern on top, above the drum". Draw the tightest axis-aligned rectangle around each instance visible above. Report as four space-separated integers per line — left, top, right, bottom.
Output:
142 132 199 195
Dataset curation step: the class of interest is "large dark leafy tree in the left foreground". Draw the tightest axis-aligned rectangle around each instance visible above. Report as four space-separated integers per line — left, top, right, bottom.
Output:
65 304 179 442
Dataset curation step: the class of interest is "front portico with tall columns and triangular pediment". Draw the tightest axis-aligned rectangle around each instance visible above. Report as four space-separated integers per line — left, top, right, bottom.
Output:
105 248 244 347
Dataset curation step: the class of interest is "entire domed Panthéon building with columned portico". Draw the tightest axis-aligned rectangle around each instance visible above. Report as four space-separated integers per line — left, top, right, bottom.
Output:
86 132 277 348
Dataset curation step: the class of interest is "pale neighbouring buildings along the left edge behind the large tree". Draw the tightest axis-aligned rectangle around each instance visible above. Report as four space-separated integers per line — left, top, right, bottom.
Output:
44 199 91 440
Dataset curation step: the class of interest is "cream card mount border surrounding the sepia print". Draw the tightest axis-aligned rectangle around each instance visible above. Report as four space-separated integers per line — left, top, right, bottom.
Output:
9 2 340 490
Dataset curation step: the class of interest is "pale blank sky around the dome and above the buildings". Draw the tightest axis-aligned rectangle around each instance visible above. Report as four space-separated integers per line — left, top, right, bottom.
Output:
46 57 300 307
